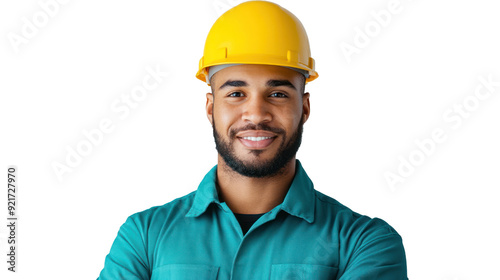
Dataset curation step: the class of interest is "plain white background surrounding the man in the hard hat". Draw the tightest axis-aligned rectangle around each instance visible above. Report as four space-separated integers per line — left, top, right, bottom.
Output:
0 0 500 280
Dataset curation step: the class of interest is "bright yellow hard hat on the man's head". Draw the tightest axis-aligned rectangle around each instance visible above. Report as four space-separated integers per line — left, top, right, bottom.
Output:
196 1 318 84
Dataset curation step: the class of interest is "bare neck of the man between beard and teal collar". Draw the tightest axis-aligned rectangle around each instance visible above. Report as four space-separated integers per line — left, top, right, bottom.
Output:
217 156 296 214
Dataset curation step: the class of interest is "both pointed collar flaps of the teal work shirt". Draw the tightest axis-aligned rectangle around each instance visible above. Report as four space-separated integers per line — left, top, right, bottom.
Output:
186 160 315 223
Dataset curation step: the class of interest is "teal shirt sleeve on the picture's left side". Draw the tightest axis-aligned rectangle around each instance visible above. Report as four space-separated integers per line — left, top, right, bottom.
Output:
97 216 151 280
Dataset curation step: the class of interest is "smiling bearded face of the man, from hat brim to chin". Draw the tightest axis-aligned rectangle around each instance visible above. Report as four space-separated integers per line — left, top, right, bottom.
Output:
207 65 309 177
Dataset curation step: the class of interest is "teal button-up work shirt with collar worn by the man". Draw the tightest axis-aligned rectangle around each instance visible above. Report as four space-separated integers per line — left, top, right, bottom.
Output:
98 160 407 280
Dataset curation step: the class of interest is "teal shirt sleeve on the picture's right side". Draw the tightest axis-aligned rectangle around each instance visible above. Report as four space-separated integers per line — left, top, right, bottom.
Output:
339 220 408 280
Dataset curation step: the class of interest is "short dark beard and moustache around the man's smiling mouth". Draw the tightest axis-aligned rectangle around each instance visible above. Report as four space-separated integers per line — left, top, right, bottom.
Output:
213 115 304 178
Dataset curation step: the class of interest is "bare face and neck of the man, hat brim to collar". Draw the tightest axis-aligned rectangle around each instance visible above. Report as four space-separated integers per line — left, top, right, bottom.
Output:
206 64 309 217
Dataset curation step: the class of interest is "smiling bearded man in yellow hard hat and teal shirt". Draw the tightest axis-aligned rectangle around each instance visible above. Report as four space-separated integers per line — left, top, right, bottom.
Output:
99 1 407 280
